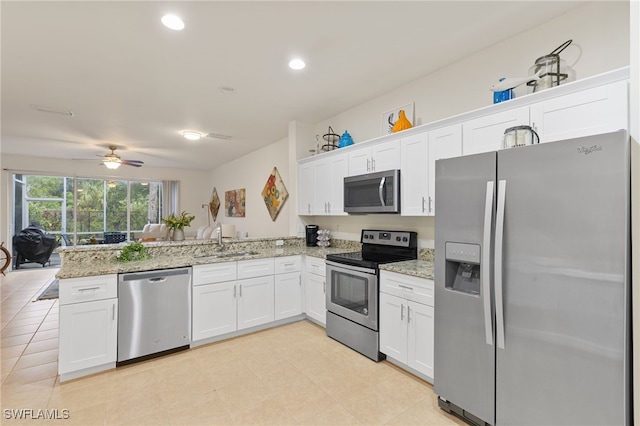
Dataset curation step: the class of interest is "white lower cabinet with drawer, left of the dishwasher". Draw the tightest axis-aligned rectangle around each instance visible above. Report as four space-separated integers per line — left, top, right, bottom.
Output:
58 274 118 381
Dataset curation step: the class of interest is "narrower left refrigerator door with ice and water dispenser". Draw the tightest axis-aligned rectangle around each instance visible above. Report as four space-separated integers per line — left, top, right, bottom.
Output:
434 152 496 424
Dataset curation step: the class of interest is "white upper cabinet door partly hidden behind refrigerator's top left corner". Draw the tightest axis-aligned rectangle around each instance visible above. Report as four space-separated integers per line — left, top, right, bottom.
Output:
426 124 462 216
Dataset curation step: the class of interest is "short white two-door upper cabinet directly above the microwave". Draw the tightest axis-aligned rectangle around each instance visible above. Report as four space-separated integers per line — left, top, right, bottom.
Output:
349 139 400 176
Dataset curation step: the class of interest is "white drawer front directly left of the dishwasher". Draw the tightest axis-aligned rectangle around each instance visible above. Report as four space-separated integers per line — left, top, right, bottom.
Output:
59 274 118 306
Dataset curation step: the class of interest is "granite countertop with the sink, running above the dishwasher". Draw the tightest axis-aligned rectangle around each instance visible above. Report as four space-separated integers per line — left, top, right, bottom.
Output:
56 247 349 279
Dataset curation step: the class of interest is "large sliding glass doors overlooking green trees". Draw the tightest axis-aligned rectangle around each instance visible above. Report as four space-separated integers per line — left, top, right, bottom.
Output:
13 174 172 244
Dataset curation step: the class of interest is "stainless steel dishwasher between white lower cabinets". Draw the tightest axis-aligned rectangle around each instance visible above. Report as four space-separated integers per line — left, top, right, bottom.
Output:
118 267 191 364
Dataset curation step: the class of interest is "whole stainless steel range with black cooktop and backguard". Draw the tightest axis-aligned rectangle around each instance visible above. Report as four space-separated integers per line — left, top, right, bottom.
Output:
326 230 418 361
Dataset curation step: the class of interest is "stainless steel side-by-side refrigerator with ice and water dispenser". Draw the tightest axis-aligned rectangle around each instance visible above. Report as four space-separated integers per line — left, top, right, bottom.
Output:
434 131 632 426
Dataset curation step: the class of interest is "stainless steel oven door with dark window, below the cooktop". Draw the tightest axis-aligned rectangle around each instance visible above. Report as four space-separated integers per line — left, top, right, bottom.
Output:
326 261 378 331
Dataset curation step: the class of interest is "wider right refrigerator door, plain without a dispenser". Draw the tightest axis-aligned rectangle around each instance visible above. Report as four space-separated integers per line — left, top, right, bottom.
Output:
496 132 631 425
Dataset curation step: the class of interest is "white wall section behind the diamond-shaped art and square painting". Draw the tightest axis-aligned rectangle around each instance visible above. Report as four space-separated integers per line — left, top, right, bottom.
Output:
208 139 296 237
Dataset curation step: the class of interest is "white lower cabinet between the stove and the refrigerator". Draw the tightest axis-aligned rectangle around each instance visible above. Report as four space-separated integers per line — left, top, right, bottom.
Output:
380 271 434 379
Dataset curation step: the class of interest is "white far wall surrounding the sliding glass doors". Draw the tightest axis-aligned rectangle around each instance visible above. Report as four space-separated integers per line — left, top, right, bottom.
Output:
0 154 210 242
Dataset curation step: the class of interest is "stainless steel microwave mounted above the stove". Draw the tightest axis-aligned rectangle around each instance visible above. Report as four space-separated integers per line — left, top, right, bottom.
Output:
344 170 400 214
